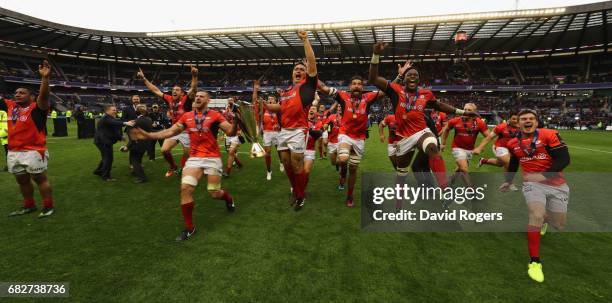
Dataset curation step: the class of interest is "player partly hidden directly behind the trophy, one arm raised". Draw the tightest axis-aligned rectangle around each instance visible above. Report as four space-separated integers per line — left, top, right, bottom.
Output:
252 81 283 181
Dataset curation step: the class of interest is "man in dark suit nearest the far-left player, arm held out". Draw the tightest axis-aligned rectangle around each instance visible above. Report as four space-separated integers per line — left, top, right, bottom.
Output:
94 105 135 181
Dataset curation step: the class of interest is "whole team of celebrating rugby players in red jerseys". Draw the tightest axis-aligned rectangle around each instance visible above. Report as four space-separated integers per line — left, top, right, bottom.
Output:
0 31 570 282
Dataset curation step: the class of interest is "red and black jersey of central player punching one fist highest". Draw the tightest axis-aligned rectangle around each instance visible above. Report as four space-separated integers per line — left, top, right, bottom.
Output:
279 76 318 129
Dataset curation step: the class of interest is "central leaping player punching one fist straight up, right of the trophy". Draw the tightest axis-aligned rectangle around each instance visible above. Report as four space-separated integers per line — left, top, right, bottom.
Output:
264 31 317 210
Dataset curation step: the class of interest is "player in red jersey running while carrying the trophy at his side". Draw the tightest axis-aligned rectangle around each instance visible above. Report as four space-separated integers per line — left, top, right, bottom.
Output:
134 91 237 241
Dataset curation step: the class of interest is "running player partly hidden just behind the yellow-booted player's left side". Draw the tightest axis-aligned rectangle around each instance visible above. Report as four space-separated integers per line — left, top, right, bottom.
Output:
473 114 518 191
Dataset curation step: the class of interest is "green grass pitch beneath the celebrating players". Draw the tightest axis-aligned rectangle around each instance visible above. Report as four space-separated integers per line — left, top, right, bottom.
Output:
0 123 612 302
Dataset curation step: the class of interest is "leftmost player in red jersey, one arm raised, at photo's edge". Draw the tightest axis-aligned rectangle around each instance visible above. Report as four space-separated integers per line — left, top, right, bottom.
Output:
0 60 54 218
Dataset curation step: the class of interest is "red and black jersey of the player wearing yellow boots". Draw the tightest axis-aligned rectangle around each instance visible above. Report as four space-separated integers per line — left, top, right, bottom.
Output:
506 128 565 186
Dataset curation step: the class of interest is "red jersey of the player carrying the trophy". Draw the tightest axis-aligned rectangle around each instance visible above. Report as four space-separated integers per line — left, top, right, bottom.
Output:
177 109 226 158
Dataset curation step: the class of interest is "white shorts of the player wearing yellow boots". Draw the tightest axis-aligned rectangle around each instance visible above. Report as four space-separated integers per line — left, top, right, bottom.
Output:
523 182 569 213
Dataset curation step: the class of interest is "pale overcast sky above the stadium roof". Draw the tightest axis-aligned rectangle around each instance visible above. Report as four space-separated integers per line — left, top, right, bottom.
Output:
0 0 597 32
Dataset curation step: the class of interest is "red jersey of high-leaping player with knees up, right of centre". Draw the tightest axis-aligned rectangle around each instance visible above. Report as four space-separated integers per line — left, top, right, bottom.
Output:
385 82 436 138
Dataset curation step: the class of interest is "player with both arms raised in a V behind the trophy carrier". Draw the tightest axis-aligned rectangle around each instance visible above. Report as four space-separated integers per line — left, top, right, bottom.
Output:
136 66 198 178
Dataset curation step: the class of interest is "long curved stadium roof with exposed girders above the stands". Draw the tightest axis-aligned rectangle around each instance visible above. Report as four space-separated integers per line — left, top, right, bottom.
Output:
0 1 612 64
